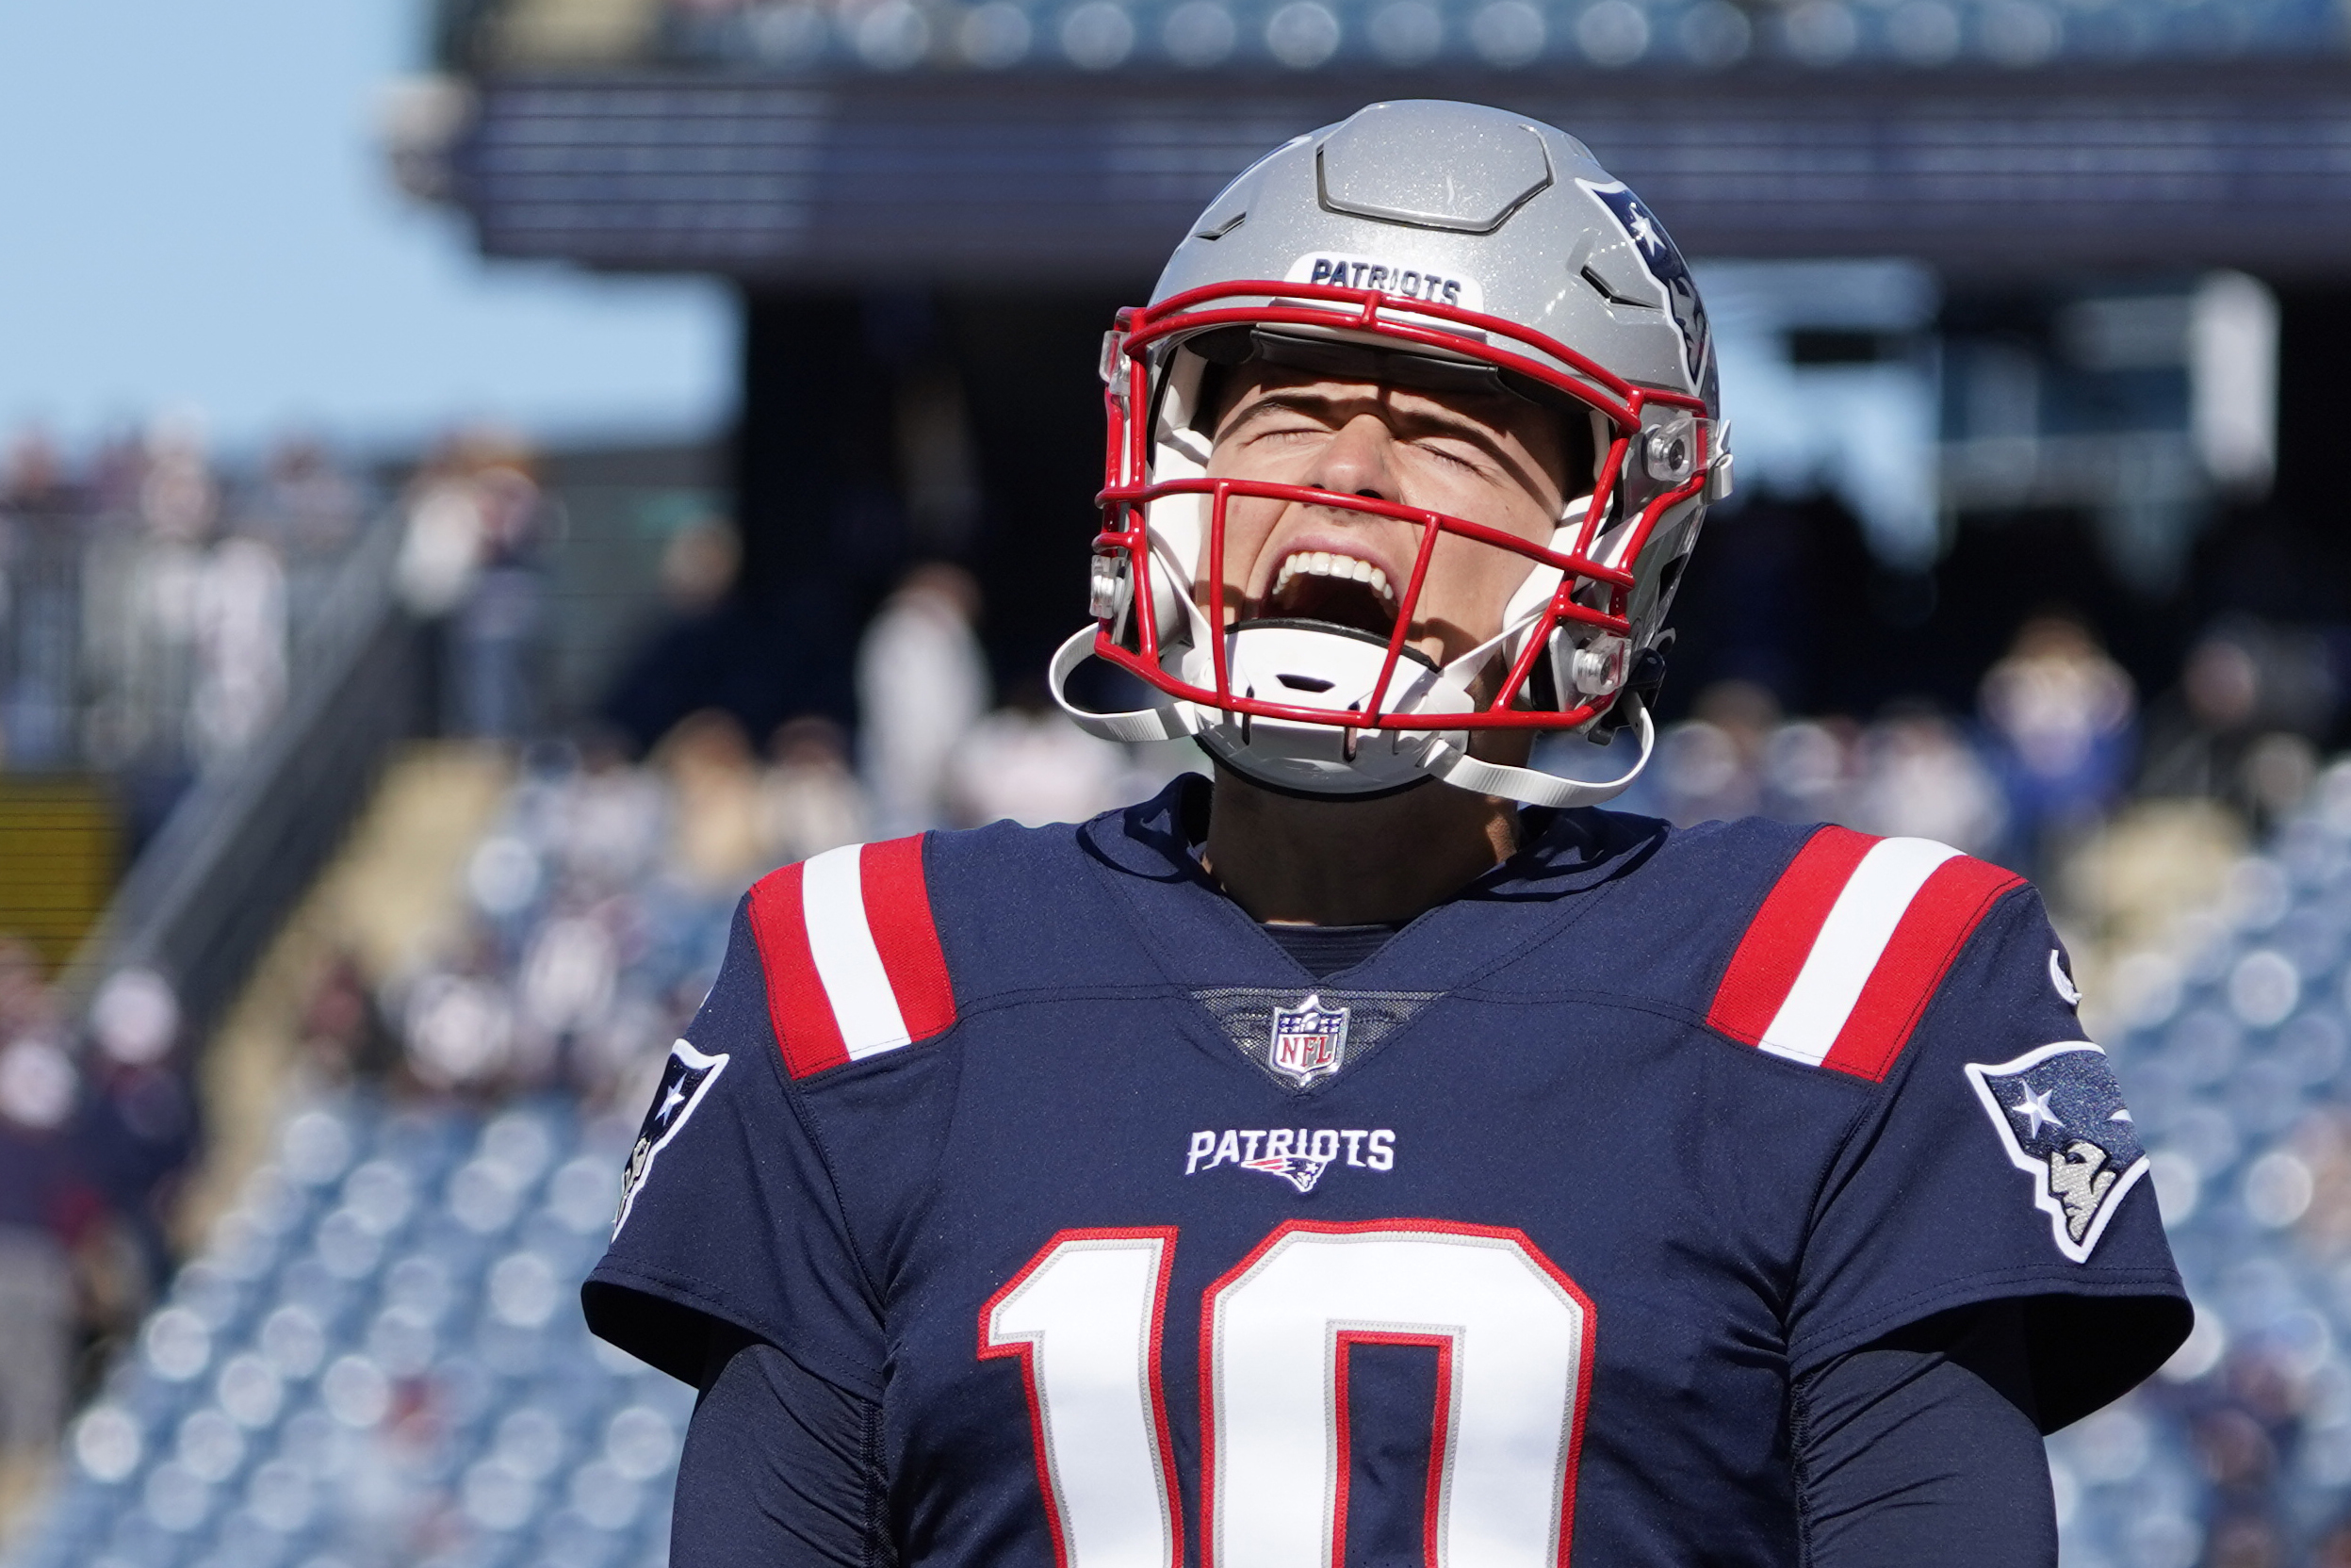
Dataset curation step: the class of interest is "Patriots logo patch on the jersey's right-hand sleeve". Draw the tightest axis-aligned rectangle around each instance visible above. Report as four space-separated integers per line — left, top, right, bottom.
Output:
1966 1039 2147 1263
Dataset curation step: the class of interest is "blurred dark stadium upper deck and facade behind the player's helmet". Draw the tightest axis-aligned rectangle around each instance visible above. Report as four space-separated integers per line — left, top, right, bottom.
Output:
385 0 2351 728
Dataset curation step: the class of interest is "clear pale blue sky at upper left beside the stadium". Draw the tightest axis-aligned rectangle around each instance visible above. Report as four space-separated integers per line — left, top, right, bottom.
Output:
0 0 736 460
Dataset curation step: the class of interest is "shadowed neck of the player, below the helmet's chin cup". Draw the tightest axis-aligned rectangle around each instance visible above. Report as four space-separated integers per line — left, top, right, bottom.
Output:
1201 769 1519 926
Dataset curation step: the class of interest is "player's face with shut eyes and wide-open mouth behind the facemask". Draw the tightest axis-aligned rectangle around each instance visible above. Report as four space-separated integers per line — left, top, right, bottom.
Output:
1194 365 1590 665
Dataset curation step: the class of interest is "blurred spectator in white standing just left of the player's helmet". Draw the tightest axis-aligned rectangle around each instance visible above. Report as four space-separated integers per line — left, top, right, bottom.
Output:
856 562 988 837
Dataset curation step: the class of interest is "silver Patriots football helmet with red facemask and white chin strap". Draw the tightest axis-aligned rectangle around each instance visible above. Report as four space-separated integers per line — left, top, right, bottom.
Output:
1051 101 1730 807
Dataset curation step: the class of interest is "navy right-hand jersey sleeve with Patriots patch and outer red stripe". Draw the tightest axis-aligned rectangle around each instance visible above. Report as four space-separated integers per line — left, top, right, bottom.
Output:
1763 870 2191 1429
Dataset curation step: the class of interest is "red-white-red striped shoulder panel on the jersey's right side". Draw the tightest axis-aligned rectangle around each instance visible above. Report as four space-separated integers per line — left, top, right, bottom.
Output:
1706 825 2048 1082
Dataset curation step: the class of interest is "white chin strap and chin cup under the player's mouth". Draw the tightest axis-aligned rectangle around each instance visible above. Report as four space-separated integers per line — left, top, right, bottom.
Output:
1046 626 1657 808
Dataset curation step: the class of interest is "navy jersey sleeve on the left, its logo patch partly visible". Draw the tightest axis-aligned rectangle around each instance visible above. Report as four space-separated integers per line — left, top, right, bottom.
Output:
580 898 884 1398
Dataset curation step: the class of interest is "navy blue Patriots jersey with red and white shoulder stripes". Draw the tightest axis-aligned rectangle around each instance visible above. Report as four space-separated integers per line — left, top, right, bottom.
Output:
585 780 2186 1568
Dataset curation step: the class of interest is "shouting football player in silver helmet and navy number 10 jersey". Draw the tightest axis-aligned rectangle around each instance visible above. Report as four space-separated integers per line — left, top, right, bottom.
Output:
585 104 2189 1568
